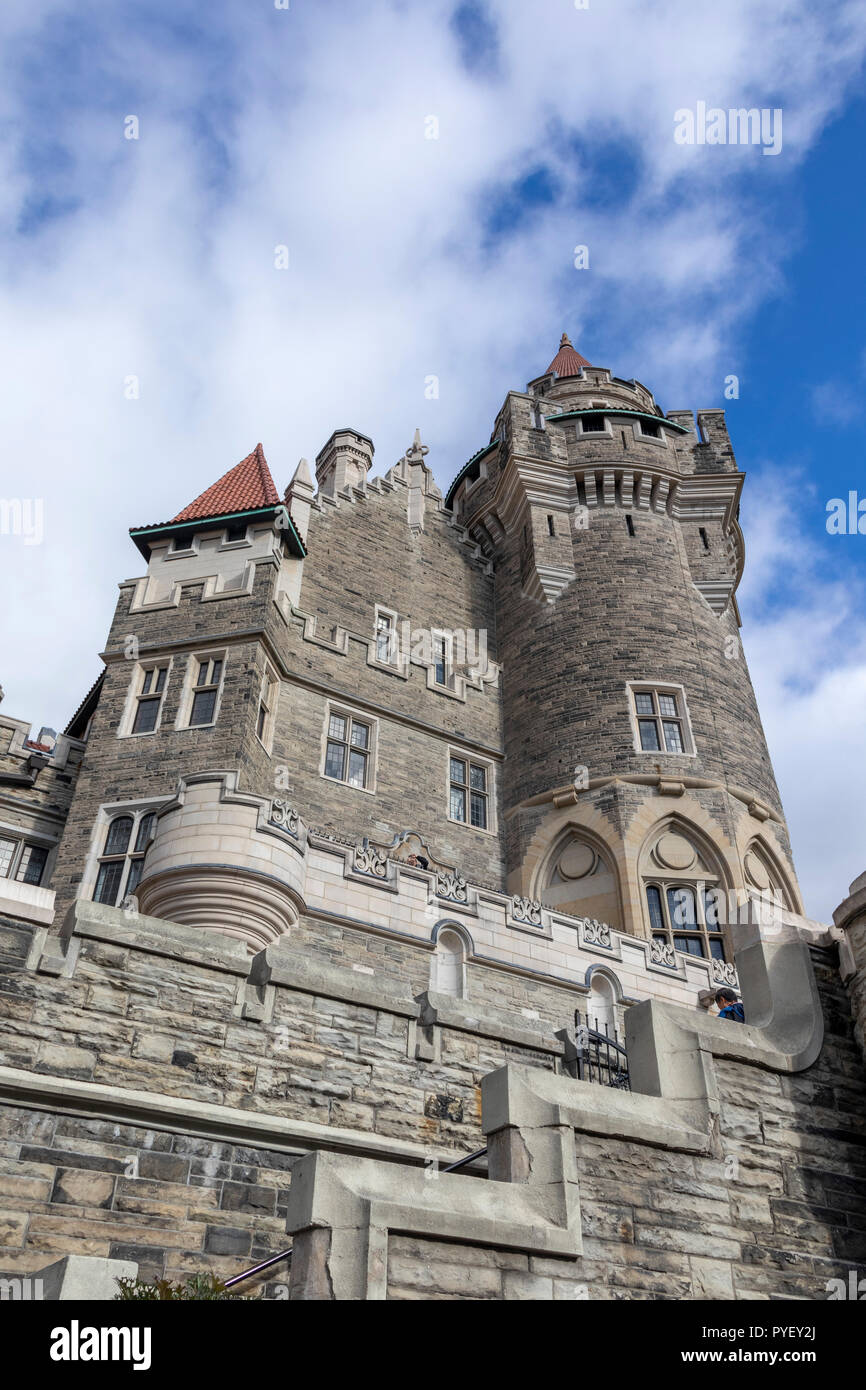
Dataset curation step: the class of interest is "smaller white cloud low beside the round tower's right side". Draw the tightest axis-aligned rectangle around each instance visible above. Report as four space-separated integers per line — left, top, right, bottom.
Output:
740 470 866 922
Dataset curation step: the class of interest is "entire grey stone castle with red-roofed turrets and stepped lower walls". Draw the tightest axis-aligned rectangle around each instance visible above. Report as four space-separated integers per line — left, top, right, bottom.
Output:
0 335 866 1300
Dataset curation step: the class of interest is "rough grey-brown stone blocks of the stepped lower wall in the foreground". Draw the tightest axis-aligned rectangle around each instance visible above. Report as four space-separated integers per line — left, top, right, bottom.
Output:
0 909 866 1300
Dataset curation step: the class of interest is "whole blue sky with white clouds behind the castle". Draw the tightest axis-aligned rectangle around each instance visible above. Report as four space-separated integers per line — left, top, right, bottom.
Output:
0 0 866 917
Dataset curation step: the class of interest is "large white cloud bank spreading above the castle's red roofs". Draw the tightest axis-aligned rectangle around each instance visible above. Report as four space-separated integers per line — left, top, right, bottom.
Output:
0 0 866 917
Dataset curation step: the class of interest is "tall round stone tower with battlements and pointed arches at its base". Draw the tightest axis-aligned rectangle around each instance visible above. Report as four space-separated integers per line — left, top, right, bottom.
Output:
448 334 802 963
